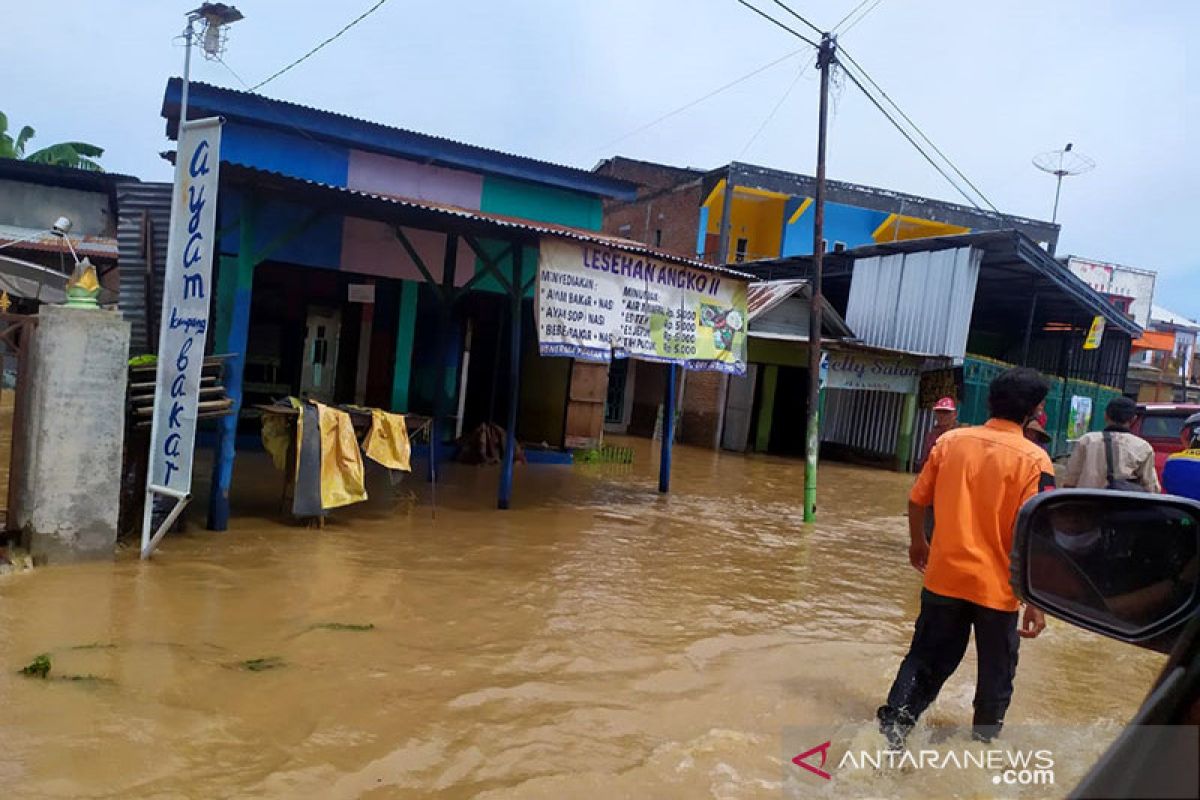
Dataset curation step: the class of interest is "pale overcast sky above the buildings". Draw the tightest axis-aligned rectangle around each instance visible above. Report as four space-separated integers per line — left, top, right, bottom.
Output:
0 0 1200 318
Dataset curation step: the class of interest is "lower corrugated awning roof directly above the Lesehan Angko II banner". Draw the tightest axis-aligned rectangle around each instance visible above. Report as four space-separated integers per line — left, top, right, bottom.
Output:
221 161 752 281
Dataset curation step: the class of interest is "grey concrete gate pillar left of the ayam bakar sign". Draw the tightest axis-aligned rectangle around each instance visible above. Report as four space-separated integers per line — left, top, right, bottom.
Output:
12 306 130 564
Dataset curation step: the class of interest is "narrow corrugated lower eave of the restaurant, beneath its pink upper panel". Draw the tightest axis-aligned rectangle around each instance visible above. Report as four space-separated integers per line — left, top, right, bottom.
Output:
221 162 752 281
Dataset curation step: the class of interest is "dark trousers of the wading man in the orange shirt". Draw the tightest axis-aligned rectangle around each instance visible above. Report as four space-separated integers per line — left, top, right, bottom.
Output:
878 589 1020 739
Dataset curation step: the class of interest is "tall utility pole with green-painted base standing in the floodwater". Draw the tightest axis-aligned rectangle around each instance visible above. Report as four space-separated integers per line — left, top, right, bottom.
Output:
804 32 838 522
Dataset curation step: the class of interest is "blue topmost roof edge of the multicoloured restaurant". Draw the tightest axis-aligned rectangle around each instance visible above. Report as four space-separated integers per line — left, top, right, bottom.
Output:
162 78 637 200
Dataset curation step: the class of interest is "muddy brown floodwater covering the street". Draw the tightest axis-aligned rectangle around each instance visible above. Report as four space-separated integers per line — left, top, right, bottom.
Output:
0 440 1162 798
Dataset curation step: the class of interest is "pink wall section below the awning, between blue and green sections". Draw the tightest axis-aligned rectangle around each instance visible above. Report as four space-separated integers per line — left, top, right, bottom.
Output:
342 217 475 287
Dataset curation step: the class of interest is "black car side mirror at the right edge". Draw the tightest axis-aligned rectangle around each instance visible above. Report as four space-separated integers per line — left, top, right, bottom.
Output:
1012 489 1200 651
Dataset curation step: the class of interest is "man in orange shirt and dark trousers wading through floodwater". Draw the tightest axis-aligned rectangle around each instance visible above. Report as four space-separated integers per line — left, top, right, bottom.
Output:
877 368 1054 748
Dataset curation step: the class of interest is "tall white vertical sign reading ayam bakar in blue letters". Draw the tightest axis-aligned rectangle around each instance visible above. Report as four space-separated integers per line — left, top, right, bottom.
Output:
142 118 221 559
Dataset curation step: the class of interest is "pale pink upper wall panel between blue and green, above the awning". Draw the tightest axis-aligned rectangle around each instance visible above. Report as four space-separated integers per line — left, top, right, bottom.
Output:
347 150 484 210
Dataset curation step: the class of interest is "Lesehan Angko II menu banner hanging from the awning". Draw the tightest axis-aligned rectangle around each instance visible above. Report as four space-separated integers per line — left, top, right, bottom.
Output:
536 239 746 375
